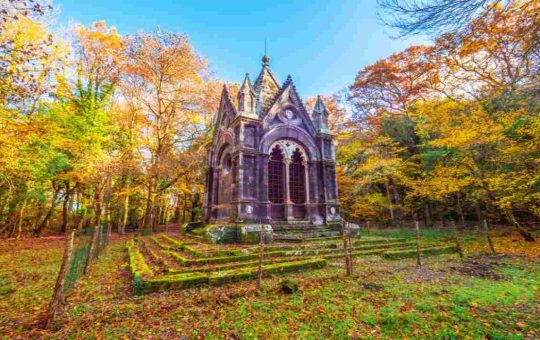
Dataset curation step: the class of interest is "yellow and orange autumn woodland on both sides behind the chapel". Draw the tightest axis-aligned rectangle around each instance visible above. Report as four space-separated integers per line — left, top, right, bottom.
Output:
0 0 540 239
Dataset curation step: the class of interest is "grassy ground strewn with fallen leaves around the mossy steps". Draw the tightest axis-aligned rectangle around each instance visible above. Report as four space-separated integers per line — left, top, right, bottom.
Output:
0 230 540 339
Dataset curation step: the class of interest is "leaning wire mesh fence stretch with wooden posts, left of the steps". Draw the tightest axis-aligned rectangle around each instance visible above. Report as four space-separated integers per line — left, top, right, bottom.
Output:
44 225 109 328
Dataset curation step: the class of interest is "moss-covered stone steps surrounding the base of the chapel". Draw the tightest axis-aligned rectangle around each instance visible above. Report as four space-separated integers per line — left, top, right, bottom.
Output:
127 233 455 293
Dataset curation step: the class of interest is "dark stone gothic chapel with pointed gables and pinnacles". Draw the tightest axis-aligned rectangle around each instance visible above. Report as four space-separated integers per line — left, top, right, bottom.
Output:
205 56 340 225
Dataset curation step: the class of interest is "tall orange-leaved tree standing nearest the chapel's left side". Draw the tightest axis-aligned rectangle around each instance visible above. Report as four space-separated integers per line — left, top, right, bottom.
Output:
123 30 212 229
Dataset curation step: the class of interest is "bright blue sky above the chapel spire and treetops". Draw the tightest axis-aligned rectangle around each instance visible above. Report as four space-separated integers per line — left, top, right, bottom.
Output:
54 0 422 96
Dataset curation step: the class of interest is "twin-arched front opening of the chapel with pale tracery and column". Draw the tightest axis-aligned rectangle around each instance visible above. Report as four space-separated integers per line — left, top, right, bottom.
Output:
268 140 309 220
